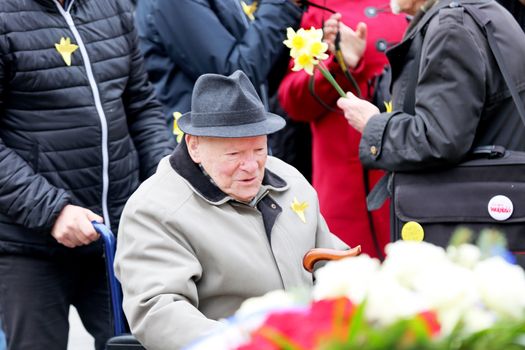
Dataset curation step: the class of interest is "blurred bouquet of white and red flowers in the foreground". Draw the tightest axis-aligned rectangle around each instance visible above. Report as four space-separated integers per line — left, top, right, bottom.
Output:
187 232 525 350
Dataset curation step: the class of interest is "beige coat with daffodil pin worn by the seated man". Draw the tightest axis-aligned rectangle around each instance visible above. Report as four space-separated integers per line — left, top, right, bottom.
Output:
115 157 347 350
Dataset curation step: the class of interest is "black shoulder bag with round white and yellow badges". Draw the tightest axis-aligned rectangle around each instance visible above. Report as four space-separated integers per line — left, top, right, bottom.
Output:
391 1 525 266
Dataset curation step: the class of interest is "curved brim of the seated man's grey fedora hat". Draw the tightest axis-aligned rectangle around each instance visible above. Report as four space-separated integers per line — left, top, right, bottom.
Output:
177 112 286 138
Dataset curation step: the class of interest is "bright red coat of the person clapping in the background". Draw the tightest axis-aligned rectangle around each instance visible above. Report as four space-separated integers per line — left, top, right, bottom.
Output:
279 0 407 256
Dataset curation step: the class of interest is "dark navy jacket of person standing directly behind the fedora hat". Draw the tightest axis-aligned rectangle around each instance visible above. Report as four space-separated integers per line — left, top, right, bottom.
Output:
136 0 302 126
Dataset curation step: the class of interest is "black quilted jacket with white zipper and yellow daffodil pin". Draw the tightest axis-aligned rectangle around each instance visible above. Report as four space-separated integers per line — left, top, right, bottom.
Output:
0 0 168 254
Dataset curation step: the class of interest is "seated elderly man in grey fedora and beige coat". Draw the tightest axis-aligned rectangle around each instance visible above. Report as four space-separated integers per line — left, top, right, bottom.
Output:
115 71 345 350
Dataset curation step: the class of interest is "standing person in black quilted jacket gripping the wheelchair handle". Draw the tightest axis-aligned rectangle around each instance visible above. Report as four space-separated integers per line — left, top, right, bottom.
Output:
0 0 169 350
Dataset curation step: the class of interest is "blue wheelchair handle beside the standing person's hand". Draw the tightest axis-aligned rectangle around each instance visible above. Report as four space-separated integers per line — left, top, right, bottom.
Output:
92 221 126 336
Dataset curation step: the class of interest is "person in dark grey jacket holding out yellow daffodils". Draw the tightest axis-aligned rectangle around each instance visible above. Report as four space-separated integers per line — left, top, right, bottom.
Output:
338 0 525 175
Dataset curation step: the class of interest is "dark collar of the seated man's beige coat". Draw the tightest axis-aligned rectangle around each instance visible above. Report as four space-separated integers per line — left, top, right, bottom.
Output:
169 139 288 205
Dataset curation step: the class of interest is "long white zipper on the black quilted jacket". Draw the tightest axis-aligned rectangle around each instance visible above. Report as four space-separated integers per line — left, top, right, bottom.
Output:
54 0 111 227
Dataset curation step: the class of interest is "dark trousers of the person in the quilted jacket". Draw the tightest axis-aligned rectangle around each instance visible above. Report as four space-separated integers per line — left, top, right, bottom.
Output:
0 255 112 350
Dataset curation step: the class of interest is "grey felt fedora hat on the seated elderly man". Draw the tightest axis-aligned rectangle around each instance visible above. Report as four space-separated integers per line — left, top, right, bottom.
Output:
177 70 286 137
